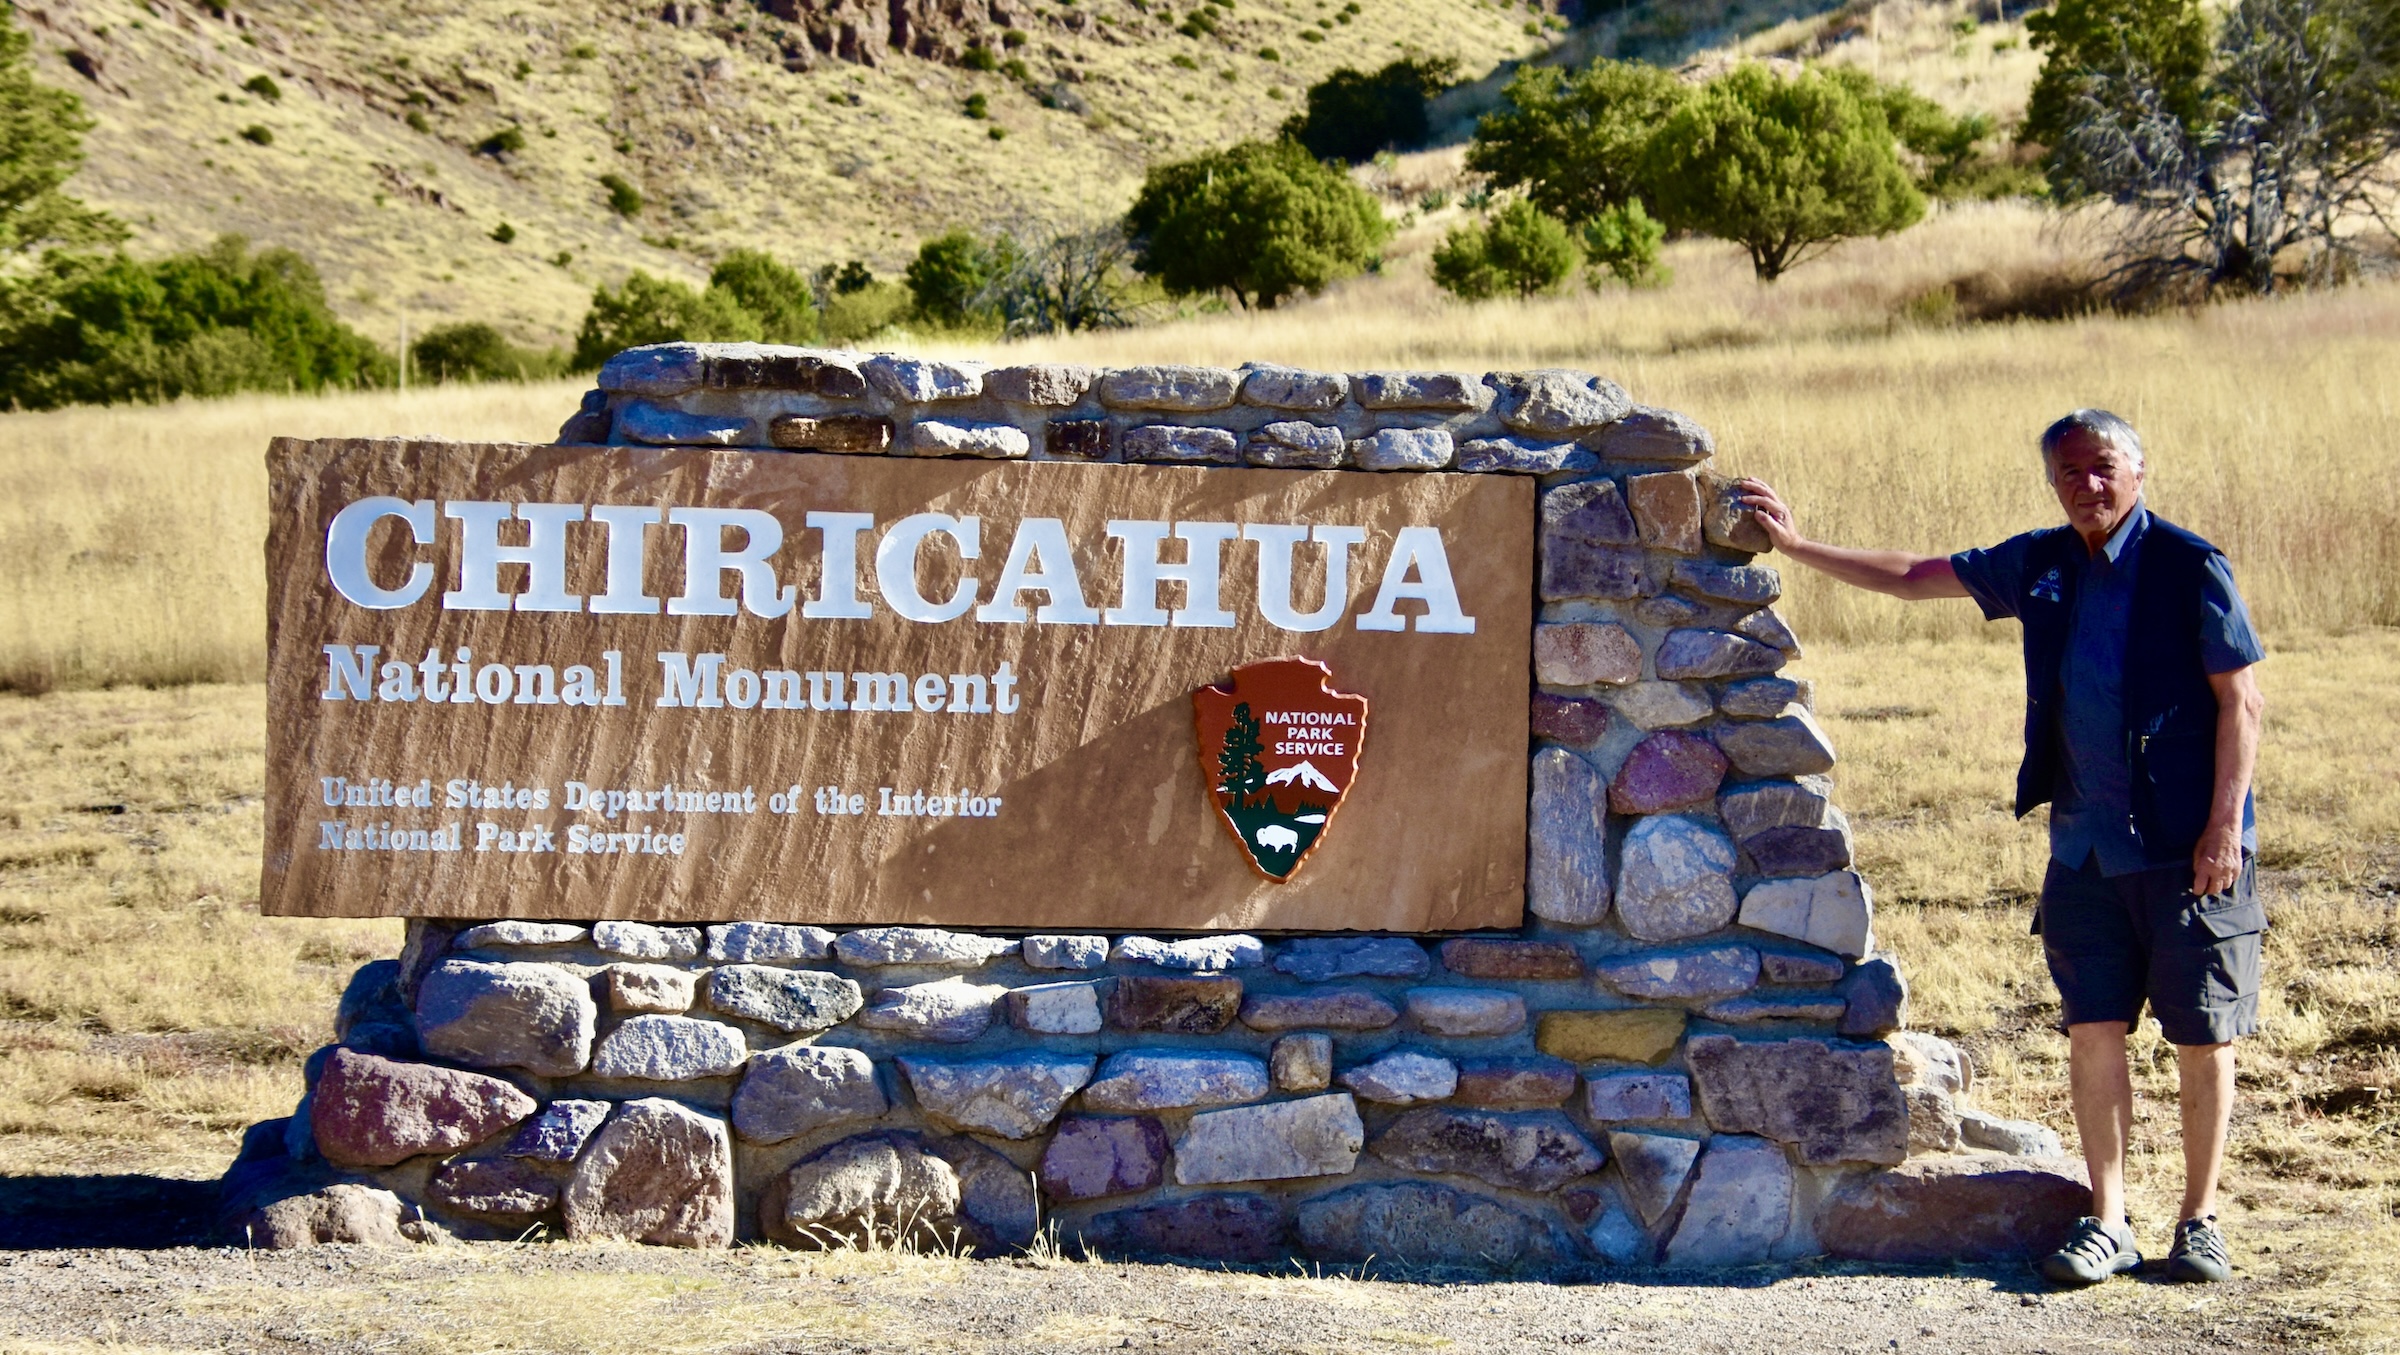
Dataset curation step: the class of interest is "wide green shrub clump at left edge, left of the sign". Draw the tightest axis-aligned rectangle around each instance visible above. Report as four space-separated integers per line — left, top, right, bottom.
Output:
0 235 394 408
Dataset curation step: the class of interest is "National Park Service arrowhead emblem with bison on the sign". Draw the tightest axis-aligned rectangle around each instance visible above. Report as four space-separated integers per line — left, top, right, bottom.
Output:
1193 657 1366 883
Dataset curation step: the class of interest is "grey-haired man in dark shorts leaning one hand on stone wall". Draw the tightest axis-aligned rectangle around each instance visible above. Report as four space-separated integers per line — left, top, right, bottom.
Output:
1740 410 2266 1283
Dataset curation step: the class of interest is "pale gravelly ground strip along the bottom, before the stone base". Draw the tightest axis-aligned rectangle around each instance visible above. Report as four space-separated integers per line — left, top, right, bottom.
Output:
0 1175 2326 1355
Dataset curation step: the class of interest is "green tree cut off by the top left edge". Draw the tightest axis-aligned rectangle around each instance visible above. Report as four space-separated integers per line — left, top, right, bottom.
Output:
0 7 125 271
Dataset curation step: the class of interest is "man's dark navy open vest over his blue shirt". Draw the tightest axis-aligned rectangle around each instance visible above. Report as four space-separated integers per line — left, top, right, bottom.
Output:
2016 513 2249 866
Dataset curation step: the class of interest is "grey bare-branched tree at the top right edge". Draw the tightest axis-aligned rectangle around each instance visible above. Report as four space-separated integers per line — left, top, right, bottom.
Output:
2045 0 2400 295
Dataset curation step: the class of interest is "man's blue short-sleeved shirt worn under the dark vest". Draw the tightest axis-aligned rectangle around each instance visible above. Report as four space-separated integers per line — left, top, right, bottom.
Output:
1951 504 2266 875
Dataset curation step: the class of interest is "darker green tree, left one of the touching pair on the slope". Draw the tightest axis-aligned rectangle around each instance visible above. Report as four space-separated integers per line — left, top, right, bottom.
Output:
1466 60 1692 225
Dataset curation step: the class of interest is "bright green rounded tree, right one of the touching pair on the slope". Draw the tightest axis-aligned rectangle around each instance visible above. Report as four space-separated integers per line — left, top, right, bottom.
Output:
1644 65 1925 283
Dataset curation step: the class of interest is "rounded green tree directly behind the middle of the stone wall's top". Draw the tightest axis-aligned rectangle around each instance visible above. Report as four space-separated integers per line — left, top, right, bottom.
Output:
1126 141 1392 309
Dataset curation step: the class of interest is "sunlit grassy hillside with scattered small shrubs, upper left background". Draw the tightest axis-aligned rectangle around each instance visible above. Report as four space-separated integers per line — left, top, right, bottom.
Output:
17 0 1555 345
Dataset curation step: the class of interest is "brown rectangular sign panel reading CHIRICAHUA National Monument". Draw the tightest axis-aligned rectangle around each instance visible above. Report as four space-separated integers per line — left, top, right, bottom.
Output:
262 439 1534 931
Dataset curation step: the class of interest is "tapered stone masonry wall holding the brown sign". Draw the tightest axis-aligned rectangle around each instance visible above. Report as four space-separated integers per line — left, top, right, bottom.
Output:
226 345 2088 1276
